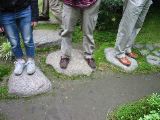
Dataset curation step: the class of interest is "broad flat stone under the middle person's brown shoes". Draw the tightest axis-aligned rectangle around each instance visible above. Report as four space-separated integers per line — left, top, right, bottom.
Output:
46 49 93 76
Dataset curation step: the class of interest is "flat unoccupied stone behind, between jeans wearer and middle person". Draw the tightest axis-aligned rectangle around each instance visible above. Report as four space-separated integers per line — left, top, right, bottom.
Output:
33 30 61 47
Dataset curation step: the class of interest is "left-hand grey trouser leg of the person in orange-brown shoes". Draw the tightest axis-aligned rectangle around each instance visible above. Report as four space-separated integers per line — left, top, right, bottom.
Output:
115 0 146 58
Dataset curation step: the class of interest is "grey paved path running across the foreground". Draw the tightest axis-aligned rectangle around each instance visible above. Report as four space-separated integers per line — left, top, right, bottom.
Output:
0 72 160 120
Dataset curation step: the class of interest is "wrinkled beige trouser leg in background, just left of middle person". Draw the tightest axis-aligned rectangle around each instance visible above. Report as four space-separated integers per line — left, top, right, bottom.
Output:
49 0 63 24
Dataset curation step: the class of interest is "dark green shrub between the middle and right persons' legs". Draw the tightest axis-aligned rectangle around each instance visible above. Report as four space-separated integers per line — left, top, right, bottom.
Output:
97 0 123 30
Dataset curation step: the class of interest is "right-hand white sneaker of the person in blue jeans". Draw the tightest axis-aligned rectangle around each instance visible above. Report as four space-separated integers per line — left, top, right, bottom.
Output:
26 59 36 75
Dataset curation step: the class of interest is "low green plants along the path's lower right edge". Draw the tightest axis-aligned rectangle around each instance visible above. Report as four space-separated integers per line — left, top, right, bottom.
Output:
107 94 160 120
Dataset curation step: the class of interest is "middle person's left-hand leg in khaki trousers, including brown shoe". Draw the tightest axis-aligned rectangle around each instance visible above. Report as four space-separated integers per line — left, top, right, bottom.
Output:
60 4 80 69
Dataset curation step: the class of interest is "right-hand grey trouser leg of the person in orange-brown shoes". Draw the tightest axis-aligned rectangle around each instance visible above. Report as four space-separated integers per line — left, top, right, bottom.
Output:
126 0 152 57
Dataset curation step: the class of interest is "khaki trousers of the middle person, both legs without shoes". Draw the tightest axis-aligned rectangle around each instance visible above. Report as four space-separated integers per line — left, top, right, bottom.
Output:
61 0 101 58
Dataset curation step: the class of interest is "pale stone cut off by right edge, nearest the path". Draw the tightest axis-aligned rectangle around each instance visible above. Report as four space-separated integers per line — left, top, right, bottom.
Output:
146 55 160 66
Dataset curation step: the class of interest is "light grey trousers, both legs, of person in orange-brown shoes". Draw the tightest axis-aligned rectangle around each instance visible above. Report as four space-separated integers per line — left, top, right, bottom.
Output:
115 0 152 58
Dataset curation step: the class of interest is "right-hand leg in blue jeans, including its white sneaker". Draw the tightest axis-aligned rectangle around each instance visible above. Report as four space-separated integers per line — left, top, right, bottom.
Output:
17 7 36 74
